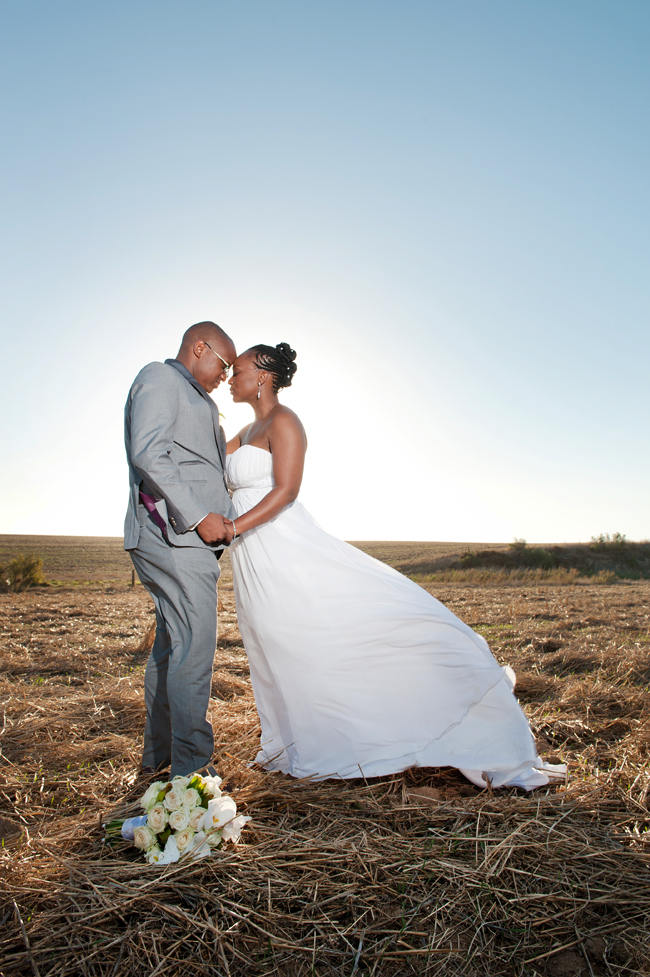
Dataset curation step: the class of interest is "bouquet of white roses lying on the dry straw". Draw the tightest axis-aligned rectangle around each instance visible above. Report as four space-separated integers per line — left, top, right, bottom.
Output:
104 774 250 865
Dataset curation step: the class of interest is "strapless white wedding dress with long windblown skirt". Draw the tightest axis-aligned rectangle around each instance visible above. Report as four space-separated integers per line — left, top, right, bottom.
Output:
226 444 566 790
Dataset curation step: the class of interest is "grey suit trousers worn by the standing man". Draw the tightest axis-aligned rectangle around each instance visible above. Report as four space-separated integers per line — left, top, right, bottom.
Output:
130 520 220 777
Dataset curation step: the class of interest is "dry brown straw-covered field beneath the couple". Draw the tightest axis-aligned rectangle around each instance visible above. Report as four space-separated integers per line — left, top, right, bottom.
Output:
0 537 650 977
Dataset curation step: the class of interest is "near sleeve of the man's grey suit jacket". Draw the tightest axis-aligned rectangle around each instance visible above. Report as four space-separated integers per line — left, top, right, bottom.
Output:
130 363 206 533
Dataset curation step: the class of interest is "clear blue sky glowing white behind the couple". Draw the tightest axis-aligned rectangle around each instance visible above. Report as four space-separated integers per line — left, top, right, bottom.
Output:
0 0 650 541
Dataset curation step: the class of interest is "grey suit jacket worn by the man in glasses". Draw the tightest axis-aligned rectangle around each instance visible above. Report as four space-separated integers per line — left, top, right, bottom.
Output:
124 360 233 550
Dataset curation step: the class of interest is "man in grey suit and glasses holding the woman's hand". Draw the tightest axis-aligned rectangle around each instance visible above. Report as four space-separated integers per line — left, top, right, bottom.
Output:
124 322 236 777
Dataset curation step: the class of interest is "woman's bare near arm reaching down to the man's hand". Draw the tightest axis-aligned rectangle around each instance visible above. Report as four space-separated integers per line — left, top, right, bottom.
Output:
225 412 307 536
